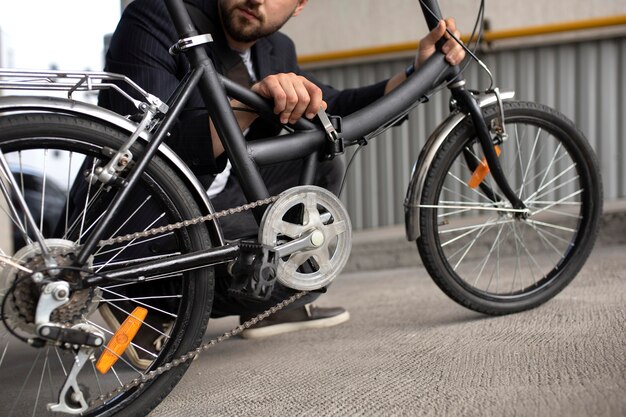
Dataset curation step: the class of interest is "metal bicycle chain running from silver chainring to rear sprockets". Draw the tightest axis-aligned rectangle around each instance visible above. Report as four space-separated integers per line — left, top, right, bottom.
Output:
89 196 308 407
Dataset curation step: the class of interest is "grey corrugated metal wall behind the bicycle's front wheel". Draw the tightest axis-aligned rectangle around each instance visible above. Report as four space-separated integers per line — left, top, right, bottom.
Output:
309 37 626 229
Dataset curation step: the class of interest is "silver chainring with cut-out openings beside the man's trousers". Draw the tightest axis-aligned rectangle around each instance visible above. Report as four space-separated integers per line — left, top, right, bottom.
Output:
259 185 352 291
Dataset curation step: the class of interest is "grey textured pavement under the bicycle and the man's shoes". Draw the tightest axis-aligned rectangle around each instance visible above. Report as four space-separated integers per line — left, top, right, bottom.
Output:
152 242 626 417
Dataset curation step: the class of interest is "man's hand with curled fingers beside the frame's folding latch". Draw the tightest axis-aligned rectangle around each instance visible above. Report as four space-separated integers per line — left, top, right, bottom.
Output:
252 73 326 124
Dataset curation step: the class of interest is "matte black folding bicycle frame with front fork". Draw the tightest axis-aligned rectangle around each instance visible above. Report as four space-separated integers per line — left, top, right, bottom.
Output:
76 0 523 286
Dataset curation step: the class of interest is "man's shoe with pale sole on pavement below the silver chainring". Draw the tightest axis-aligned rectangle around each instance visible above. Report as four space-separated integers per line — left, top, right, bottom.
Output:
239 304 350 339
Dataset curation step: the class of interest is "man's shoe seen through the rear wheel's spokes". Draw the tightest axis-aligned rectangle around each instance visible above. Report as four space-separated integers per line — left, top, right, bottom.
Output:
98 303 172 370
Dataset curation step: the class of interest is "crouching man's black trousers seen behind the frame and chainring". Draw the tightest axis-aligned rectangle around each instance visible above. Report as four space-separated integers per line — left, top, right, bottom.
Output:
203 158 345 317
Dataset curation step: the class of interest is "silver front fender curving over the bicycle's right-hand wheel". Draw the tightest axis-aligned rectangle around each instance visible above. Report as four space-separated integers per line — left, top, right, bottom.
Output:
404 91 515 241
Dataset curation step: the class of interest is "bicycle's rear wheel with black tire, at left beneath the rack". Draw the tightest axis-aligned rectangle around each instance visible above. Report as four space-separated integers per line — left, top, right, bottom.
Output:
0 114 213 416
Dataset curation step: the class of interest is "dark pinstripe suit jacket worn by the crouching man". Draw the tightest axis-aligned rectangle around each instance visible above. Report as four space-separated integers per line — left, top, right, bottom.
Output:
99 0 386 175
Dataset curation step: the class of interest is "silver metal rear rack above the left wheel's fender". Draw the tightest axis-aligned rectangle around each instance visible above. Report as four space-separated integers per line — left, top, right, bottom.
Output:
0 69 168 114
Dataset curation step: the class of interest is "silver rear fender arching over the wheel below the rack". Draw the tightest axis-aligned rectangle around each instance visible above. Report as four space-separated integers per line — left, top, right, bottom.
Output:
0 96 224 246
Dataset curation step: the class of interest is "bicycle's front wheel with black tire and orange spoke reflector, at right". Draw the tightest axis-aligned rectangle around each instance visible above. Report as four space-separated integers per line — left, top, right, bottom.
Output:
417 102 602 315
